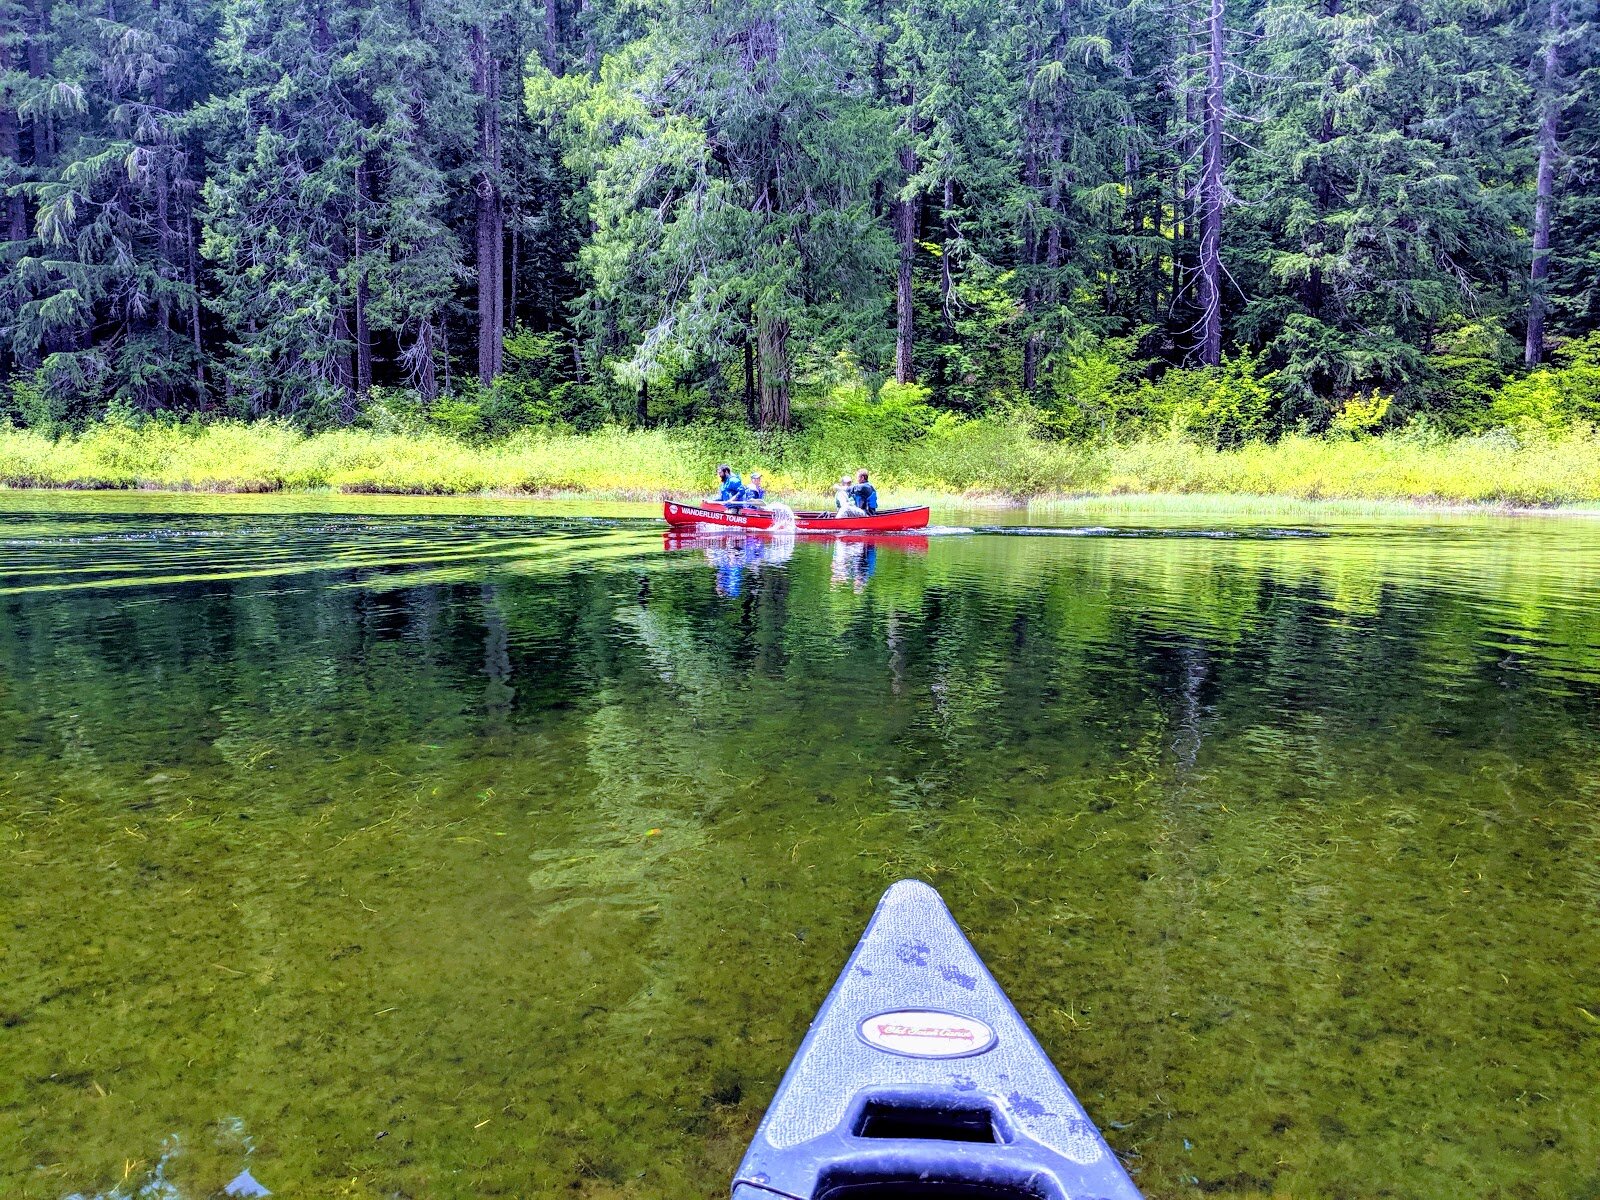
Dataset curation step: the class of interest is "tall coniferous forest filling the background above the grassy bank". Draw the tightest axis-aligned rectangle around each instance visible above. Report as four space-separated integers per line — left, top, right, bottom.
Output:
0 0 1600 443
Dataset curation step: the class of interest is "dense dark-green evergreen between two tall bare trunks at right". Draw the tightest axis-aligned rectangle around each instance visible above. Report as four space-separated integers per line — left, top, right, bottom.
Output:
1240 0 1515 419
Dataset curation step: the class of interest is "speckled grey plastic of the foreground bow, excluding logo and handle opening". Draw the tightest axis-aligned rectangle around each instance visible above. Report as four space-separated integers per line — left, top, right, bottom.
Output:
736 880 1139 1198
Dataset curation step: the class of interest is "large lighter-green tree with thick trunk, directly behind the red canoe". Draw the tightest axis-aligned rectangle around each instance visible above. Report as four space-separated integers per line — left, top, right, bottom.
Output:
547 0 888 429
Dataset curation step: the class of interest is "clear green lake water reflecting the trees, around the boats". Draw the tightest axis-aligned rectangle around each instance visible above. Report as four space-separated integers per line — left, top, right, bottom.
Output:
0 494 1600 1200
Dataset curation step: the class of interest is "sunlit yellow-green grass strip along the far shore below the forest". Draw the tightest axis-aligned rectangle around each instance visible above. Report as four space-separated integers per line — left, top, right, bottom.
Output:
0 421 1600 506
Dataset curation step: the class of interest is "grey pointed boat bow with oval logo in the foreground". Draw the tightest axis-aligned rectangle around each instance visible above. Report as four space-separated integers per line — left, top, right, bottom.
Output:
733 880 1139 1200
